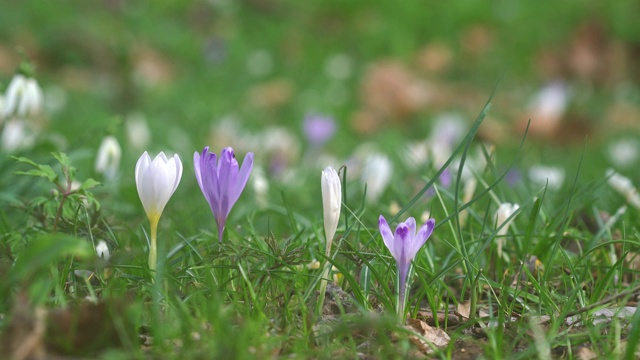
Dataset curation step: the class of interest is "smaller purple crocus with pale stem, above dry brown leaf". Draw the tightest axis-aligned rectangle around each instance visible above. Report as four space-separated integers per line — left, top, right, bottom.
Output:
378 215 436 318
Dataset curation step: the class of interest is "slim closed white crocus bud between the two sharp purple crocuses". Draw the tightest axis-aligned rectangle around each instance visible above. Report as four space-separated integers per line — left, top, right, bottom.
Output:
320 166 342 250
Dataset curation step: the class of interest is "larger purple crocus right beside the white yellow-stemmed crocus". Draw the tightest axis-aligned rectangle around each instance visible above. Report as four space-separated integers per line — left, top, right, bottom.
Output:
193 146 253 241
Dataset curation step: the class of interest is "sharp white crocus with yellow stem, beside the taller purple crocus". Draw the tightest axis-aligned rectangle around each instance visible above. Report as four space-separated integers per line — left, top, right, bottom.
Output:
136 151 182 270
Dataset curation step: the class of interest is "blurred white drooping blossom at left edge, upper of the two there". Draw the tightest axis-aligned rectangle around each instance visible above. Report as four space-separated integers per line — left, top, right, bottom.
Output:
2 74 44 119
